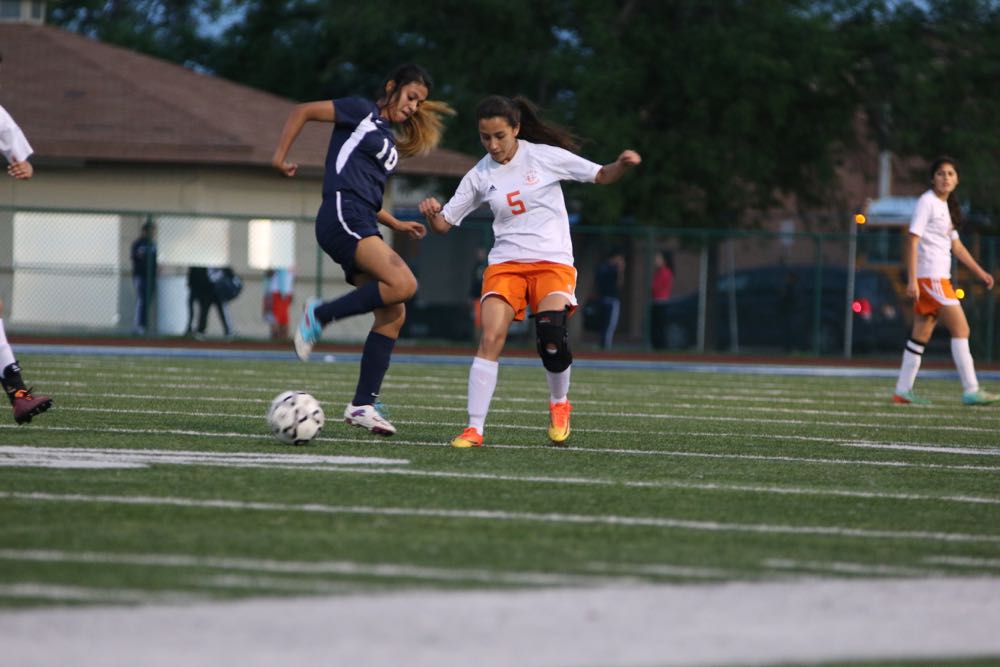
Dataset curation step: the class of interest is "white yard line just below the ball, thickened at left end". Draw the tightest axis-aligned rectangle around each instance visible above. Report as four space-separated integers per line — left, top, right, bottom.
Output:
0 446 1000 505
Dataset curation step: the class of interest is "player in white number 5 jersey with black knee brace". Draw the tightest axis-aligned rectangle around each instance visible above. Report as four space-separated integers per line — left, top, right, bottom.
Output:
420 95 641 448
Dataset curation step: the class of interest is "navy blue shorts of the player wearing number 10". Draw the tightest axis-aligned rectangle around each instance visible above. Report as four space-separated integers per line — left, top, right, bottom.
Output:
316 192 382 285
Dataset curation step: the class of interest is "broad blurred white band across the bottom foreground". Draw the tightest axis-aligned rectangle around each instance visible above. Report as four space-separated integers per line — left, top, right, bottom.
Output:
0 578 1000 667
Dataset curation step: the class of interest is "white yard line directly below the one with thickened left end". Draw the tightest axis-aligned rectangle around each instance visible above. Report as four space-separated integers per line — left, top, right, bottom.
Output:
0 491 1000 544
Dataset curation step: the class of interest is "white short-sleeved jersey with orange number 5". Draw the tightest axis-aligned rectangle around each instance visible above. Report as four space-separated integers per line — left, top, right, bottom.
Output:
441 140 601 266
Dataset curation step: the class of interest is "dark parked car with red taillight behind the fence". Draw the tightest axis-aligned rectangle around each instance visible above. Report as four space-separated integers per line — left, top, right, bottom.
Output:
666 266 907 353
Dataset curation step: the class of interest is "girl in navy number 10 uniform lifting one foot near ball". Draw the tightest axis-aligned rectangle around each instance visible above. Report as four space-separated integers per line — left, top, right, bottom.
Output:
272 64 453 435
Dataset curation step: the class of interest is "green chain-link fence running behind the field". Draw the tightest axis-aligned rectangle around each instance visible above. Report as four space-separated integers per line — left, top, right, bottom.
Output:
0 207 1000 361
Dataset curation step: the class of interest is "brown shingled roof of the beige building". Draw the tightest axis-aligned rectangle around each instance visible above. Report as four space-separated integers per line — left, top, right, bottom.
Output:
0 23 476 176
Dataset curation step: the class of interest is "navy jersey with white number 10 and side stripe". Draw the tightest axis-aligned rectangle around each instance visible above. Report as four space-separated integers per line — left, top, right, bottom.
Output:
323 97 399 211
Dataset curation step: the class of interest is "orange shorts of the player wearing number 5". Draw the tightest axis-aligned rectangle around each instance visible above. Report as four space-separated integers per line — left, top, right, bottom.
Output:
480 262 577 321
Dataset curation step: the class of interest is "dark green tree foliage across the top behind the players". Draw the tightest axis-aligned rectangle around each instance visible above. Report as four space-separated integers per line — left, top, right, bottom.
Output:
50 0 1000 232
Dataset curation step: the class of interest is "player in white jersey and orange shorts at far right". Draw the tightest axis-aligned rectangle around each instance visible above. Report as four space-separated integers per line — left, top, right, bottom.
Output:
892 157 1000 405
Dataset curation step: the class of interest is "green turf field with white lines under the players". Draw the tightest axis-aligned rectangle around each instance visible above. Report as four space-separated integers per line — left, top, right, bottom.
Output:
0 354 1000 665
